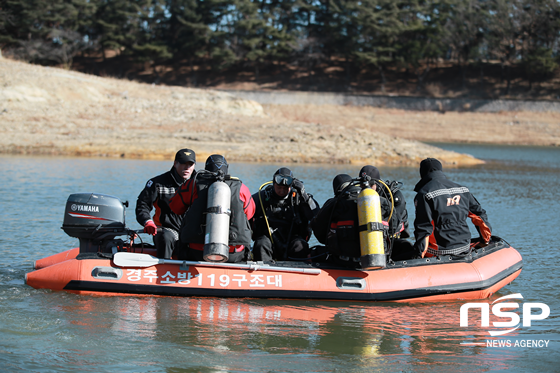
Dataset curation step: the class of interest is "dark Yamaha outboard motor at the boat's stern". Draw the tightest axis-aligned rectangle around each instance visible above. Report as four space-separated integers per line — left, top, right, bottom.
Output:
62 193 128 253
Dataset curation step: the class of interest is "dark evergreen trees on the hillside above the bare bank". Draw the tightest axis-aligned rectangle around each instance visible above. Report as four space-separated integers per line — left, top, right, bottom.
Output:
0 0 560 100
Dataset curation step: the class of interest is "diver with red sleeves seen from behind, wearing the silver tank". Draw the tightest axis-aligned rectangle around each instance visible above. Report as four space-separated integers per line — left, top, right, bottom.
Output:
169 154 255 263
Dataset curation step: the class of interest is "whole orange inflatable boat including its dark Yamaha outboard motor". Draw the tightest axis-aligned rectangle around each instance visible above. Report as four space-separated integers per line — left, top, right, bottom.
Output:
26 194 523 301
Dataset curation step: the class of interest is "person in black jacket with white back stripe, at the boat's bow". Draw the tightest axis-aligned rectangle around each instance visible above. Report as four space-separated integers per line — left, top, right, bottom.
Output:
414 158 492 258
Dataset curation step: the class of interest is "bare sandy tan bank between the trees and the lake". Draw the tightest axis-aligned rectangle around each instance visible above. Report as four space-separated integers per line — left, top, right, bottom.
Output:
0 58 560 165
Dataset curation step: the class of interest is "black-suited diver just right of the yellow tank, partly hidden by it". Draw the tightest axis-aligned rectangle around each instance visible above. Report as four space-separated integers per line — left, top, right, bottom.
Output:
358 165 415 261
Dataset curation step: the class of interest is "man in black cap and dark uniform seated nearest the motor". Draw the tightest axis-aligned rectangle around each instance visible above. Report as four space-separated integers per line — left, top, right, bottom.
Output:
136 149 196 259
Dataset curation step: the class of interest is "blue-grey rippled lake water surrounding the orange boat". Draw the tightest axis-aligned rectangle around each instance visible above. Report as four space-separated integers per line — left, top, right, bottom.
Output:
0 145 560 372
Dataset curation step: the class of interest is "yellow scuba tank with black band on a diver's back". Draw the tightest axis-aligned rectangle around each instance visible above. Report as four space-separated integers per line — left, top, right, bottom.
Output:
358 187 387 270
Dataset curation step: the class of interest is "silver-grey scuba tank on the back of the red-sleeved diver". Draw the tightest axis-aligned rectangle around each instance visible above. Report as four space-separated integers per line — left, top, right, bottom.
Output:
203 181 231 263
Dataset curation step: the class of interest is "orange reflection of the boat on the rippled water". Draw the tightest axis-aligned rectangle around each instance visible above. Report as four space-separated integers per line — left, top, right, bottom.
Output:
58 297 510 370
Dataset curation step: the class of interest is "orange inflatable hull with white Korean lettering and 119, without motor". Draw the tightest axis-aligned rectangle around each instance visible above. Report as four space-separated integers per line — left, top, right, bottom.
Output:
26 241 522 301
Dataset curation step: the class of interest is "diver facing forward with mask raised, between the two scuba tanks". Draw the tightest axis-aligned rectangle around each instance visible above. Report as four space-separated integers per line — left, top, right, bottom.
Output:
251 167 319 261
